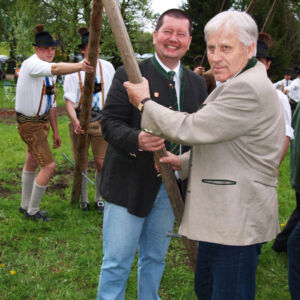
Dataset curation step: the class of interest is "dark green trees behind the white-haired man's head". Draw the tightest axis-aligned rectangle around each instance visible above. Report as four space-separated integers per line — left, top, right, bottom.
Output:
183 0 300 81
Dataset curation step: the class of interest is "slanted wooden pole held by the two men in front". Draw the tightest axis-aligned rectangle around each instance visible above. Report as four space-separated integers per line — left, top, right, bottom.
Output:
102 0 197 271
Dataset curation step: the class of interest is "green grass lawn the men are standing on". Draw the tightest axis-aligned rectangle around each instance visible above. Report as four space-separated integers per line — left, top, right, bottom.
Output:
0 111 295 300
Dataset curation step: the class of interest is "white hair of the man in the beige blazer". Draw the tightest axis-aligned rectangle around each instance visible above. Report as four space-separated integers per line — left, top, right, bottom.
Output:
204 10 258 47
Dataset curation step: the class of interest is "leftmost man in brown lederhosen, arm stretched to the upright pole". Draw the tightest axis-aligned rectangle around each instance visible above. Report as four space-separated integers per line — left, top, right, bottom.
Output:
15 25 93 221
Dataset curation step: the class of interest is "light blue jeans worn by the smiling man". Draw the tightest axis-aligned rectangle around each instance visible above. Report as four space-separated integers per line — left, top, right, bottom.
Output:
97 184 174 300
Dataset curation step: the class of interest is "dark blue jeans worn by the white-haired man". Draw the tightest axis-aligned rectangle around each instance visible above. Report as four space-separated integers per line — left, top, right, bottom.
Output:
195 242 261 300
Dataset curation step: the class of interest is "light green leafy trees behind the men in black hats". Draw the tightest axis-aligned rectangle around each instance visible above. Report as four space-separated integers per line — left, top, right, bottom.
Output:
0 0 156 72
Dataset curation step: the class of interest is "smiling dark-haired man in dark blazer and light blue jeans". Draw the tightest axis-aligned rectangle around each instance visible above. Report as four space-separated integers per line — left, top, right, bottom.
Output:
98 9 207 300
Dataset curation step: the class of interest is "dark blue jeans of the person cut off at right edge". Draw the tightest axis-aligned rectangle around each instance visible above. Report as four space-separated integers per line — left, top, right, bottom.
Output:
287 221 300 300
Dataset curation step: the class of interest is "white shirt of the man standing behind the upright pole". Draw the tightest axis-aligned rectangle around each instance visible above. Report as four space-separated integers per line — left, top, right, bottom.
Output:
63 59 115 111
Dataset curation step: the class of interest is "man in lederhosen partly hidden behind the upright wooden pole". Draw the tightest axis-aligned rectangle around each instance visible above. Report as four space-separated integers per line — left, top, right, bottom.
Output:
64 27 115 212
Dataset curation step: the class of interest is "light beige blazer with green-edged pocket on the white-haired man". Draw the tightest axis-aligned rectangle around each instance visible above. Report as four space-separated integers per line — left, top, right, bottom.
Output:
142 62 285 245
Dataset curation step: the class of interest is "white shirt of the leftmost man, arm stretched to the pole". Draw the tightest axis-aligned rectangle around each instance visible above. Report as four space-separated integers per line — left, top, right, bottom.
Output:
15 54 56 117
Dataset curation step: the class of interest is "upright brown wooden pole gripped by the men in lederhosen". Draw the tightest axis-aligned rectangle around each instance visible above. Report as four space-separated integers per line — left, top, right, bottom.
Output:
71 0 103 204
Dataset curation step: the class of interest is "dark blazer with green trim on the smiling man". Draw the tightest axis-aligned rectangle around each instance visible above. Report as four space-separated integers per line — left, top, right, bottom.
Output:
100 59 207 217
